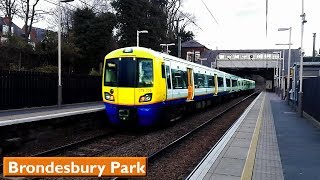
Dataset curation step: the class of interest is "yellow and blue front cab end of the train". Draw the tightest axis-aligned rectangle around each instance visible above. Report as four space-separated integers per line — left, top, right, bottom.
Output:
102 48 166 126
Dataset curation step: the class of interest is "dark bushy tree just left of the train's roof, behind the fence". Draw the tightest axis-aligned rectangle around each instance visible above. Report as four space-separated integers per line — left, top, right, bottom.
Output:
72 8 116 72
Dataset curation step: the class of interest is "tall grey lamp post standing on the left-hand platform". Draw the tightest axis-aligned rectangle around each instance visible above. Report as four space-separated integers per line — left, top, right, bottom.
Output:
58 0 74 108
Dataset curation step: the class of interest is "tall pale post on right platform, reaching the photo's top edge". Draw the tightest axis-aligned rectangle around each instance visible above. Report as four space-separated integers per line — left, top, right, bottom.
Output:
298 0 307 116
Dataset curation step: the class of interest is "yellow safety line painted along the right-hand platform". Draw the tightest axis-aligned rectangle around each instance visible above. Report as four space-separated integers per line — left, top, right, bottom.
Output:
241 94 266 180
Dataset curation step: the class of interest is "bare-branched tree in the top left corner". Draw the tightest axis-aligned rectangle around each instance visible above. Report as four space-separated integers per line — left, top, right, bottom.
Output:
0 0 18 36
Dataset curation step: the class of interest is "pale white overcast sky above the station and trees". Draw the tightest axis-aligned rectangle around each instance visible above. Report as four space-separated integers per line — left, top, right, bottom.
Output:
8 0 320 55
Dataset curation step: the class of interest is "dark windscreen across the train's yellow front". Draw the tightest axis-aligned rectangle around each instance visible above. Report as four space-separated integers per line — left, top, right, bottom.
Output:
104 58 153 87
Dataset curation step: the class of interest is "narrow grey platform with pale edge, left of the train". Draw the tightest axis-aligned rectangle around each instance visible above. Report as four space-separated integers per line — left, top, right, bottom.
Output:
0 102 104 127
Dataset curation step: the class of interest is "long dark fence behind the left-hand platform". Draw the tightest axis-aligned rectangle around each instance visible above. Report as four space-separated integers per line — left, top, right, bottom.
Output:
0 70 102 110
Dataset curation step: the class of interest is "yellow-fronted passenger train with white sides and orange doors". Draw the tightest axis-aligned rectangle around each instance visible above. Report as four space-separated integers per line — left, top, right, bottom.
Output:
102 47 255 127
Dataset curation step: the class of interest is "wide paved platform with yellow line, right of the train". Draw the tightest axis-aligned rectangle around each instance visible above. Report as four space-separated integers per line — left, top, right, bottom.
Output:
187 92 320 180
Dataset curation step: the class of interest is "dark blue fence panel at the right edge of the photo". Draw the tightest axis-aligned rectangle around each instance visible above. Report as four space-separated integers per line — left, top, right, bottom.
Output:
303 77 320 122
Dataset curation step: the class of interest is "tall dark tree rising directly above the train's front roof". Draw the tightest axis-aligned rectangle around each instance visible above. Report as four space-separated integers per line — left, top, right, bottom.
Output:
112 0 167 50
